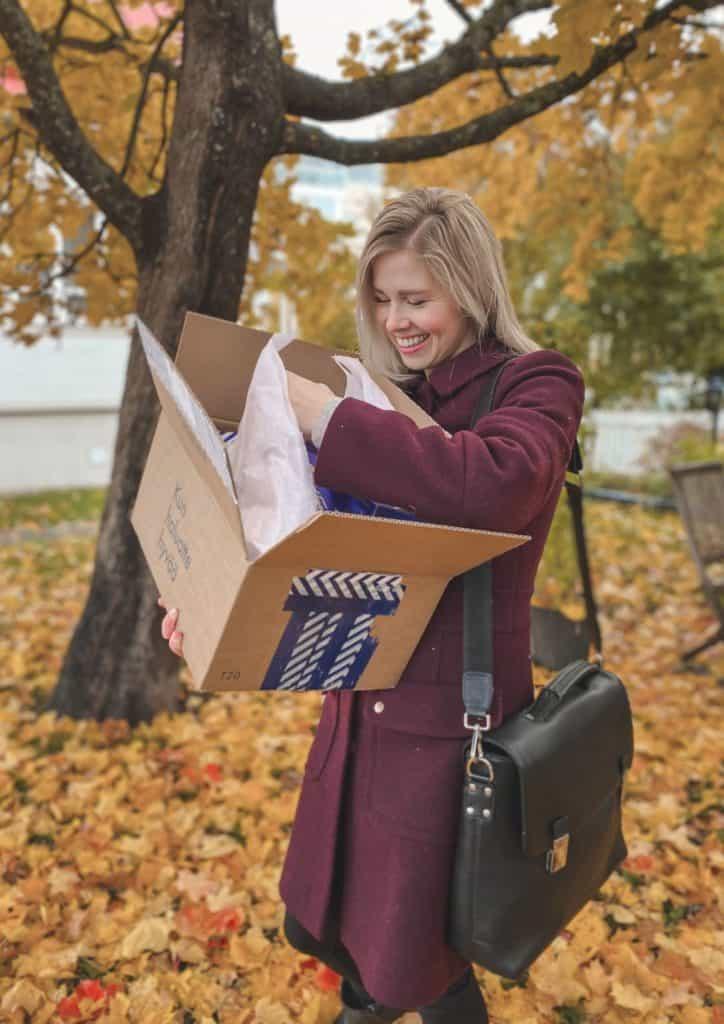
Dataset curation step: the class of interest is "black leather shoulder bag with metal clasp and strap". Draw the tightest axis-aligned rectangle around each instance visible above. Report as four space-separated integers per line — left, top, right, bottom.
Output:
448 358 634 978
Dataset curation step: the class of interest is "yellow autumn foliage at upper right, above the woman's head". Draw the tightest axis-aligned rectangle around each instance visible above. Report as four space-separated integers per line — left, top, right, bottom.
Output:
378 0 724 300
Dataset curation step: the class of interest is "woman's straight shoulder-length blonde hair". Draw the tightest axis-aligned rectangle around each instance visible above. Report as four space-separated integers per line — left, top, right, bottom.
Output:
356 188 541 383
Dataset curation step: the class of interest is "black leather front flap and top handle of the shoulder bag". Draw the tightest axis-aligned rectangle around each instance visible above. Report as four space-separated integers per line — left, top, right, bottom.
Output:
482 662 634 857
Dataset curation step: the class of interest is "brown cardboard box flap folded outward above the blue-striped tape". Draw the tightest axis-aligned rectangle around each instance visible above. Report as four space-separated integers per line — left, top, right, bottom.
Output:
253 512 530 580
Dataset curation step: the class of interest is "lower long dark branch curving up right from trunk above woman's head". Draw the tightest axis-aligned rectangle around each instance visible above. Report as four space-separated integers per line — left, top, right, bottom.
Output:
279 0 718 165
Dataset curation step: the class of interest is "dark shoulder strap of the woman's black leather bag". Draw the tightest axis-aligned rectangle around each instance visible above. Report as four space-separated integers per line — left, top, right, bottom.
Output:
463 356 601 729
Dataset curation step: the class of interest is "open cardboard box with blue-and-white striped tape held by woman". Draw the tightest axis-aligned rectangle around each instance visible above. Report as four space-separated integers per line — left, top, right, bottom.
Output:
131 313 528 690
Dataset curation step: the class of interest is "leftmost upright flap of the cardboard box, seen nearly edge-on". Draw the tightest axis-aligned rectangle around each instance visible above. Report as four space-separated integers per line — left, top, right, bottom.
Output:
136 317 246 550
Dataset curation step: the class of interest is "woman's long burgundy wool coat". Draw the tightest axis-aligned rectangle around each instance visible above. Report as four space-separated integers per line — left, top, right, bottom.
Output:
280 338 584 1010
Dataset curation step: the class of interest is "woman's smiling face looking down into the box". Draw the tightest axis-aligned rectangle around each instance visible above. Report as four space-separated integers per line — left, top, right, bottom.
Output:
372 249 475 373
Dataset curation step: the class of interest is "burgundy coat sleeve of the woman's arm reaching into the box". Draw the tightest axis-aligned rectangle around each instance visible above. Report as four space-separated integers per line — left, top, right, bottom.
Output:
314 349 584 532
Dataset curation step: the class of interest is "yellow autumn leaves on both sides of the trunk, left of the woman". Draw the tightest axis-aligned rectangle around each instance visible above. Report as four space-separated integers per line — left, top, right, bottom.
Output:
0 0 354 347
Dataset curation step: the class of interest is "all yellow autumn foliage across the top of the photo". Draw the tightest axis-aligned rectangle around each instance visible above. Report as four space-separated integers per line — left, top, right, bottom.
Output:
0 0 724 345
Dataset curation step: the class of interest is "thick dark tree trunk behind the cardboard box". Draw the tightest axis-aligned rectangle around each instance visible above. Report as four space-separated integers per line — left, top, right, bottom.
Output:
50 0 284 724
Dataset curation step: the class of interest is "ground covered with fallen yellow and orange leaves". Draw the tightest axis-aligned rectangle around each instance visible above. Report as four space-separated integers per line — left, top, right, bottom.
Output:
0 504 724 1024
